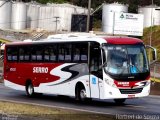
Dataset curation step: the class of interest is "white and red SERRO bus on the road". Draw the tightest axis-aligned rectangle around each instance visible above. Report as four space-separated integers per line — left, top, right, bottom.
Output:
4 35 156 103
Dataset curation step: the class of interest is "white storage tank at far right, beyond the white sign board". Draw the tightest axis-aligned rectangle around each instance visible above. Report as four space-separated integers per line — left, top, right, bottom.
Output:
138 5 160 27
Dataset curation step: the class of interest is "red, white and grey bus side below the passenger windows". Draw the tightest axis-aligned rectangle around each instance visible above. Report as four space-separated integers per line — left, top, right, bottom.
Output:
5 63 90 97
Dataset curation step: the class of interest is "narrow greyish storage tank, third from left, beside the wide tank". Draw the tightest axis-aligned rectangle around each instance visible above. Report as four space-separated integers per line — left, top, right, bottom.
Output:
27 3 40 29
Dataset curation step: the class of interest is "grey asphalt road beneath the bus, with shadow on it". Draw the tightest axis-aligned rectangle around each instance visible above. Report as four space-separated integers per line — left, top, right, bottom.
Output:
0 84 160 119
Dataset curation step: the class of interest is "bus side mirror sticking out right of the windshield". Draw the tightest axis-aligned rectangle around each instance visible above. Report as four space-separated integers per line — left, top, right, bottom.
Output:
146 45 157 64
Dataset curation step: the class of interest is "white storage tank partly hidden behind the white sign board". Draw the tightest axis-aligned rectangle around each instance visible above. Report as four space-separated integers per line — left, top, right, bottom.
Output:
102 3 128 34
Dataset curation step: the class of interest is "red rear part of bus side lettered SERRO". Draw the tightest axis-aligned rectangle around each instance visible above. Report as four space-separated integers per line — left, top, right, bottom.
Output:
4 63 61 89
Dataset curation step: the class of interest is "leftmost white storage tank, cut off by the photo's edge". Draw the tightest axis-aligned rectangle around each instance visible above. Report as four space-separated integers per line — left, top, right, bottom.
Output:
0 0 11 29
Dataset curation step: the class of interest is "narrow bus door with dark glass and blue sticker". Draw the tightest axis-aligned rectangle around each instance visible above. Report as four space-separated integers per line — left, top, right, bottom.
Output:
90 43 102 98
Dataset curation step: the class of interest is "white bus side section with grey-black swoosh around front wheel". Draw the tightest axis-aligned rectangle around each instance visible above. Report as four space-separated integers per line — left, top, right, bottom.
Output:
35 63 90 97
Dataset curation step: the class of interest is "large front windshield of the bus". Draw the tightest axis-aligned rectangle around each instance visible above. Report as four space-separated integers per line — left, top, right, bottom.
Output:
103 44 149 75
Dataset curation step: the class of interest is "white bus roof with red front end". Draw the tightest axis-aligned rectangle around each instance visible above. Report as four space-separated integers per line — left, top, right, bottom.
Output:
5 33 142 45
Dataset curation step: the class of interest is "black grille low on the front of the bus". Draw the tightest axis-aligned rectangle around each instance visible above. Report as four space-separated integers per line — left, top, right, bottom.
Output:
119 88 143 94
